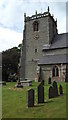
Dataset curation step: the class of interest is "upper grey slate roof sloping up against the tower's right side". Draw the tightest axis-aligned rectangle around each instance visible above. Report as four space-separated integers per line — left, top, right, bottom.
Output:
42 33 68 51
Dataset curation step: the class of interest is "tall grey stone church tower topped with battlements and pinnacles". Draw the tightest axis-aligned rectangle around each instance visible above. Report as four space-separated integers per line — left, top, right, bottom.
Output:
20 7 57 80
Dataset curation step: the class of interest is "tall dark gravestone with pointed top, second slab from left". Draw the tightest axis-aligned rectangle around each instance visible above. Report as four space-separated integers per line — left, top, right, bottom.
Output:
37 83 44 103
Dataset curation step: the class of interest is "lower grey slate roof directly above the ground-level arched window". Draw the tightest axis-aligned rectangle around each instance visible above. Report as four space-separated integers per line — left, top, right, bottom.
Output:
38 54 68 65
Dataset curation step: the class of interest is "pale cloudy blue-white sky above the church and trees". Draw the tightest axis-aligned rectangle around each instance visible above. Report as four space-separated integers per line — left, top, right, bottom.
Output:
0 0 66 52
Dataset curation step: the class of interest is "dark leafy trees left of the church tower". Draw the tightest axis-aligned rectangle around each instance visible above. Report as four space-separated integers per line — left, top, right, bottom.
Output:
2 47 20 81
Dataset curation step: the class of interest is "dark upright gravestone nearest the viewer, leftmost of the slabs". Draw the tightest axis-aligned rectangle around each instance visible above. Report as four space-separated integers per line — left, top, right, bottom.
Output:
27 89 34 107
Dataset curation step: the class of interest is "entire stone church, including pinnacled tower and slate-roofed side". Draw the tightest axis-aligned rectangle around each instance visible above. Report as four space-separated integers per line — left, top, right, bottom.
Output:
20 7 68 81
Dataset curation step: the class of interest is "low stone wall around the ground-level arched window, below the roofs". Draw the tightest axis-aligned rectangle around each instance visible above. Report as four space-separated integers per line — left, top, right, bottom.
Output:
41 64 66 82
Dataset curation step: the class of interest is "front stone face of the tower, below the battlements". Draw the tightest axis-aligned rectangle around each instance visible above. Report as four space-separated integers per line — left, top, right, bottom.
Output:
25 17 49 79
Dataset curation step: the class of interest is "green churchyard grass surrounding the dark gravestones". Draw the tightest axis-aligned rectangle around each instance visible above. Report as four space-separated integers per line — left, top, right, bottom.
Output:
2 81 67 118
